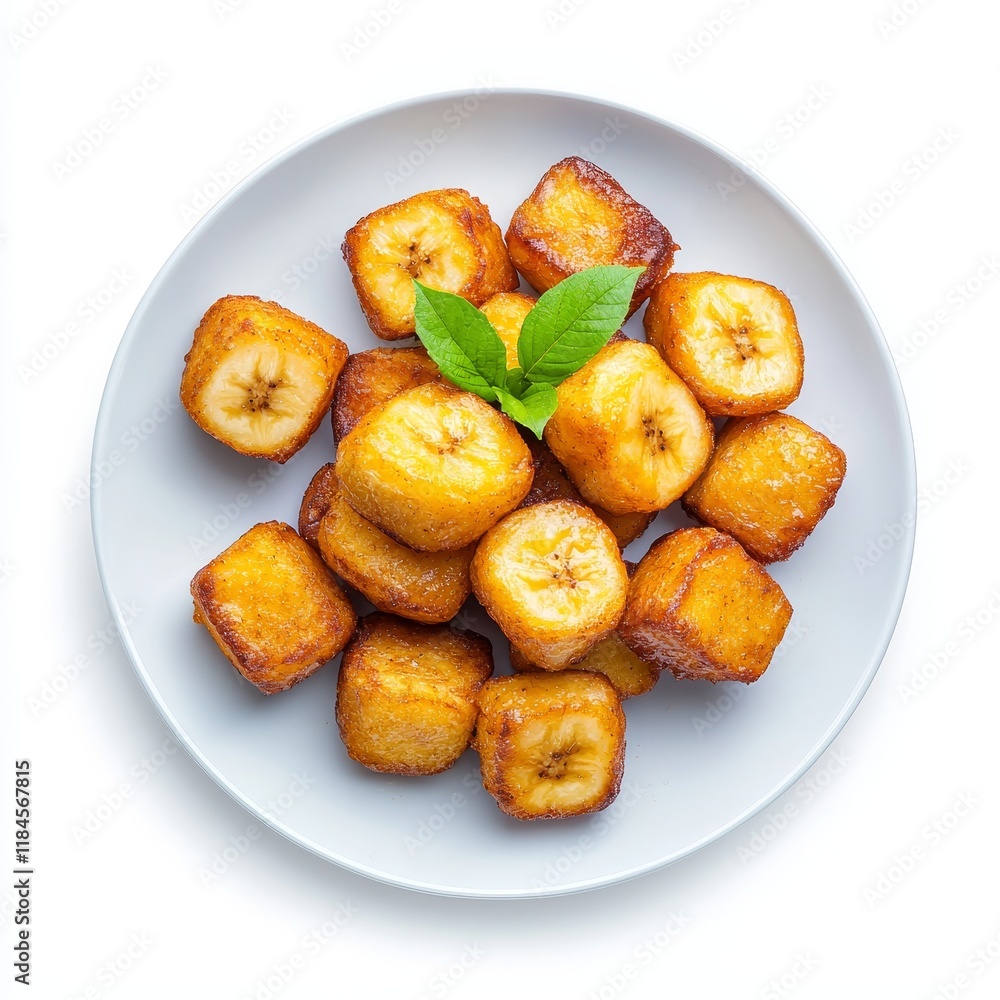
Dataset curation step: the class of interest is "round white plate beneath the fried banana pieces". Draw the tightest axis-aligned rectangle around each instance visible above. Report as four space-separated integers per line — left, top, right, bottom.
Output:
92 92 916 896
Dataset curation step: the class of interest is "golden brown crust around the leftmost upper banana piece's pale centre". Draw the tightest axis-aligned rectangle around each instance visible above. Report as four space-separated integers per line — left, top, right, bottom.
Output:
180 295 348 463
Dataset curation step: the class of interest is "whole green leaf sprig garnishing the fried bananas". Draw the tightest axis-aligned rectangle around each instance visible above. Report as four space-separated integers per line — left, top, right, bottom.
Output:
413 264 645 438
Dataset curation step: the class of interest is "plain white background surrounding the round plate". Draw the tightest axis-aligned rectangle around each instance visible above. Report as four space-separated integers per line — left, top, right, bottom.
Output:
7 0 1000 1000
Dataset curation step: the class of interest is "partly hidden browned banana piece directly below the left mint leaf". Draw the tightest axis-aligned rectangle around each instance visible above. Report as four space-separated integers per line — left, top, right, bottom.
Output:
330 347 441 443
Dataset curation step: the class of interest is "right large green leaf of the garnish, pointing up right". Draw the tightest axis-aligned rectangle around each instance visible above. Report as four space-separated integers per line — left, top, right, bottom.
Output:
517 264 645 386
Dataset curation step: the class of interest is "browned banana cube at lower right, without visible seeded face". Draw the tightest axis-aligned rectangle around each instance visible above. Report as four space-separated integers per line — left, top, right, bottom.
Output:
618 528 792 684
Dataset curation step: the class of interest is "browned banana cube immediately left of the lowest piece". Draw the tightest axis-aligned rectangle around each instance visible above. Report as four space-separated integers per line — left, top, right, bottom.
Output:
337 613 493 775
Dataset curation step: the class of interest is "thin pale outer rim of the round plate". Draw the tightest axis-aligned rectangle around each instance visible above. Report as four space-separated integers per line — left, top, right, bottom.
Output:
90 87 917 899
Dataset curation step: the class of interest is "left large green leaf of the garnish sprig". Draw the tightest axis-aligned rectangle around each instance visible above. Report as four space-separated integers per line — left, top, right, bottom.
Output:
413 280 507 403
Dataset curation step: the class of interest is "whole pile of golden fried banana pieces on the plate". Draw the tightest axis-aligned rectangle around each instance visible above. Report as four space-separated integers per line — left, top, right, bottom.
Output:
180 156 846 819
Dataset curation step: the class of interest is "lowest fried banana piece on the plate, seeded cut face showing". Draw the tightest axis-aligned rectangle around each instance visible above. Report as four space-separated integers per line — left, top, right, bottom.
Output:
472 670 625 819
